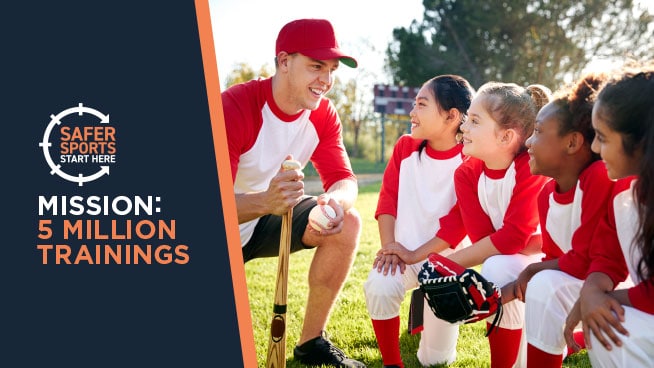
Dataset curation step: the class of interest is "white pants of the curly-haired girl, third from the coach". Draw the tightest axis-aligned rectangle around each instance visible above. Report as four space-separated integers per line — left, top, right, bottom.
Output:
525 270 584 355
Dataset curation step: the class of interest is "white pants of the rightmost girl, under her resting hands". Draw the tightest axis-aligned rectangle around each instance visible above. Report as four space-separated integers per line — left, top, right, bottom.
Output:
588 306 654 368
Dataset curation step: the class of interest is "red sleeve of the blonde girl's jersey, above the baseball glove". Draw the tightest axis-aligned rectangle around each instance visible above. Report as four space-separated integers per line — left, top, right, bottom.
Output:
490 152 551 254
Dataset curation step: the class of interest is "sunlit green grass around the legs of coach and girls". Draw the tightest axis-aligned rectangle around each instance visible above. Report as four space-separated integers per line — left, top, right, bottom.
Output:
245 178 590 368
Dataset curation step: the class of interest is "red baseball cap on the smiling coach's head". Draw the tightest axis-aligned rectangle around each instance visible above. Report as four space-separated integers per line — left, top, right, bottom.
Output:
275 19 357 68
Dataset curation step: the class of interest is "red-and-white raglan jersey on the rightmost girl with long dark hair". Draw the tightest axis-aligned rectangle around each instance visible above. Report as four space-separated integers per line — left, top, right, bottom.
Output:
588 176 654 314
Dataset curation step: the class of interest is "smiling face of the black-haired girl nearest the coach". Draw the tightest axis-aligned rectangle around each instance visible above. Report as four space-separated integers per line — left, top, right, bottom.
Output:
409 84 454 141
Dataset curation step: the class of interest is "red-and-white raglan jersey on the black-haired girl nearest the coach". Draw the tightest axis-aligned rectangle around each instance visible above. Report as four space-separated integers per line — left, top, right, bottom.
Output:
375 134 466 250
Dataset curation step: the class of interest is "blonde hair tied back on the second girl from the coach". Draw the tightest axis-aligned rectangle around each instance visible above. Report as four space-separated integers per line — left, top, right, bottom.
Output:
477 82 552 151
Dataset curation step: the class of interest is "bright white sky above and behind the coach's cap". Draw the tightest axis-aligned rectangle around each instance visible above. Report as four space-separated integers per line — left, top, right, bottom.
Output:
209 0 654 88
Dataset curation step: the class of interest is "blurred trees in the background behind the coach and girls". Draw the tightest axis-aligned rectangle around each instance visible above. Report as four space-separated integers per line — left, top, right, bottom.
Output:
225 0 654 162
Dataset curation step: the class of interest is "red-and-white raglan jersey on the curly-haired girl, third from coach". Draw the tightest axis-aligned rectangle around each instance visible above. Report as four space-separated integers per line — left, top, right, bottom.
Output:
538 161 613 279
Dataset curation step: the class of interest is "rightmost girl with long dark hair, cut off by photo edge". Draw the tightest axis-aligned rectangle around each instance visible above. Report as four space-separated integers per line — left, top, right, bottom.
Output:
564 65 654 368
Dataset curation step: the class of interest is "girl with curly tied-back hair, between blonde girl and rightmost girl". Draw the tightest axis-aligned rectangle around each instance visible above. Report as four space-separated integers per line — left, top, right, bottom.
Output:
502 74 613 367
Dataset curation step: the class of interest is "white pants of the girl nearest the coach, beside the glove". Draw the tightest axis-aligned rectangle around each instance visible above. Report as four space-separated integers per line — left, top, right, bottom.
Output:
363 262 459 366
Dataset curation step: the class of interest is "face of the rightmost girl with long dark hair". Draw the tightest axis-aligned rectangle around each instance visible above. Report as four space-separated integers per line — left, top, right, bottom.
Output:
591 100 642 180
